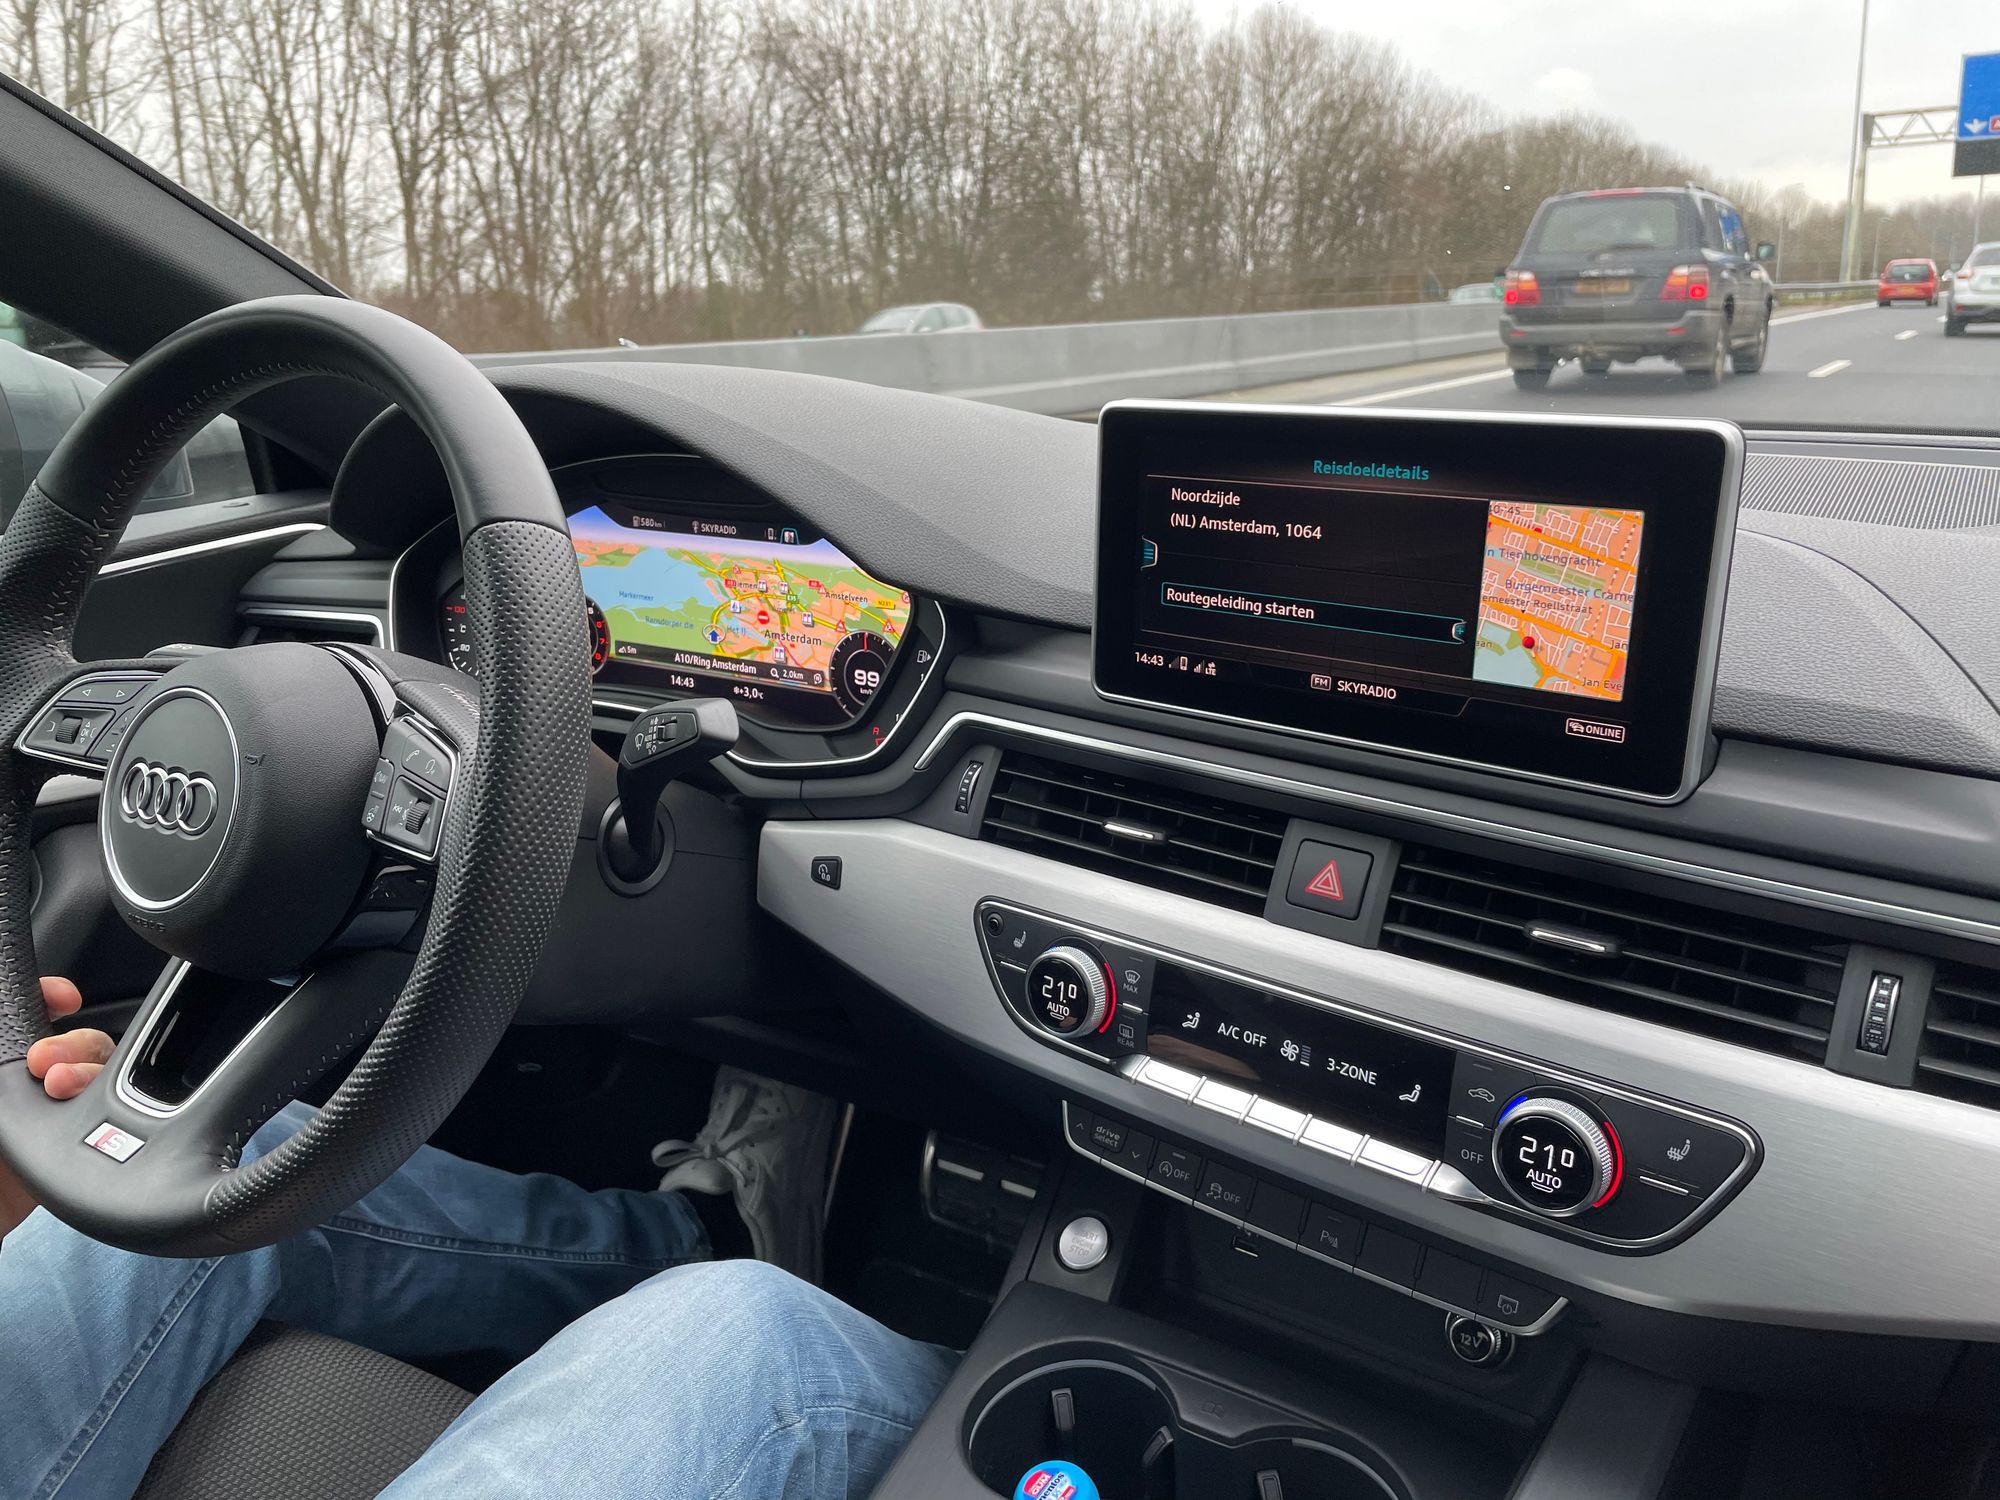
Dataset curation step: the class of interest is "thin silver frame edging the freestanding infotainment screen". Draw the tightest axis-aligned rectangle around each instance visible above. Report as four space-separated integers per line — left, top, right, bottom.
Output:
1090 400 1744 802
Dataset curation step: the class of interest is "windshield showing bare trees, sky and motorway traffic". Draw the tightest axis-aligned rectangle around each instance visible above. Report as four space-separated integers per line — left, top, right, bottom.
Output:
0 0 2000 432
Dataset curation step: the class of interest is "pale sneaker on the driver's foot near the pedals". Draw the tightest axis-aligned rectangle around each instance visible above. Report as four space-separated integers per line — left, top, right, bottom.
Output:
652 1068 838 1282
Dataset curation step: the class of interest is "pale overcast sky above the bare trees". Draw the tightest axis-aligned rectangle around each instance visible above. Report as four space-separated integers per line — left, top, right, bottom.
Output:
1194 0 2000 204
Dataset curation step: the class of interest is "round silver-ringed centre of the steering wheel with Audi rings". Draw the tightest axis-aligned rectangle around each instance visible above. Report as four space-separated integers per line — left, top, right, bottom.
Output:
100 686 238 912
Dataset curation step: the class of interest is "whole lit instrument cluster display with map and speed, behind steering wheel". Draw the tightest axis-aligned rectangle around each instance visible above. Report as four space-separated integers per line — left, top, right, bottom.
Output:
440 500 910 730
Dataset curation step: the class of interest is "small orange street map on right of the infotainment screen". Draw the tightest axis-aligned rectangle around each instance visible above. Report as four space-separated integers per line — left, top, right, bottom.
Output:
1472 500 1646 702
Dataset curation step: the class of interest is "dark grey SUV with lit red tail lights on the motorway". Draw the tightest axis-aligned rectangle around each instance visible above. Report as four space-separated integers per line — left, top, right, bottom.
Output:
1500 188 1776 390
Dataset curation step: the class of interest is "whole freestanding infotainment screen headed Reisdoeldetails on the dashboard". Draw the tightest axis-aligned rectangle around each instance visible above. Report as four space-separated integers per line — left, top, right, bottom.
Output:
1094 402 1742 800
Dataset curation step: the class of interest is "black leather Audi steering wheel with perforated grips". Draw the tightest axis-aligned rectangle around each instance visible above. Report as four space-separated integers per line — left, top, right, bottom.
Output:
0 296 590 1256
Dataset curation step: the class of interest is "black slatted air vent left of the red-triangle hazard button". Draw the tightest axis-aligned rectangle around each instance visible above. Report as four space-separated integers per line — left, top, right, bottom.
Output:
980 756 1286 912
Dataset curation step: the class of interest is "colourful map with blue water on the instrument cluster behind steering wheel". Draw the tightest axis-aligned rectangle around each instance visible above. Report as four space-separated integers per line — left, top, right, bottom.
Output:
570 508 910 692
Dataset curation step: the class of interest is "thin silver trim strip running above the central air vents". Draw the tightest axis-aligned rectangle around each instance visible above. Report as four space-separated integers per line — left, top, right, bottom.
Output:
916 710 2000 944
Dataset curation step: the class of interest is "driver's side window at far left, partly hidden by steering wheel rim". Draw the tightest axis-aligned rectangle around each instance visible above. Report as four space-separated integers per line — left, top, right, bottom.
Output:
0 302 256 518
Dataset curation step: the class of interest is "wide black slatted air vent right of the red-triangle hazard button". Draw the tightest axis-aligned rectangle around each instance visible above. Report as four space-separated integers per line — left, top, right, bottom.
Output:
1382 846 1840 1078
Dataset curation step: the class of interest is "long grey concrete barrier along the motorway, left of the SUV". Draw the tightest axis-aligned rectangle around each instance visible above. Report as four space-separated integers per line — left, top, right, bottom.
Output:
474 302 1500 416
